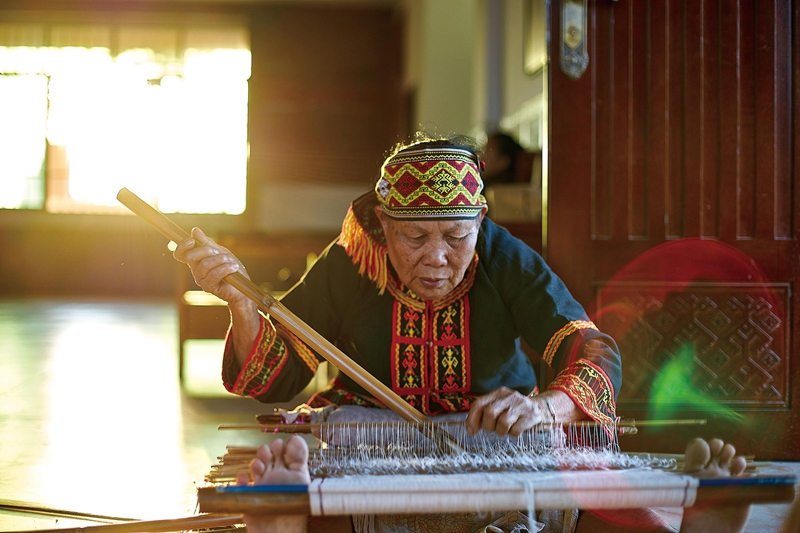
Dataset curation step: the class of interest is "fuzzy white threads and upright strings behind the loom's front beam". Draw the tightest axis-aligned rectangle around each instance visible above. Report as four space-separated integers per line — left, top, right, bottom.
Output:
206 412 664 483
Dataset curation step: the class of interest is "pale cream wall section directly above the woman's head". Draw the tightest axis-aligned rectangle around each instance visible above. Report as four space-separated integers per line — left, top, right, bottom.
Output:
401 0 544 141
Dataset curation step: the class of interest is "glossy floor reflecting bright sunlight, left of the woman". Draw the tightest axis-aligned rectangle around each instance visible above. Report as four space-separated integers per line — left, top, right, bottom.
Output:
0 300 800 532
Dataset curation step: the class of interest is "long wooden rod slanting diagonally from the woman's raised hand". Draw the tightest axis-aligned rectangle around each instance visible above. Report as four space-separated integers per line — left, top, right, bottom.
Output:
117 188 457 450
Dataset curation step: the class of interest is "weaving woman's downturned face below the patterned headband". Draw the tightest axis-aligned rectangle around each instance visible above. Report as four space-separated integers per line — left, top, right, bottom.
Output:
375 206 486 300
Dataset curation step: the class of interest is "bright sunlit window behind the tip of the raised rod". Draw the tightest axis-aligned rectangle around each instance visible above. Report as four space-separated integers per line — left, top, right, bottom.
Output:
0 24 250 214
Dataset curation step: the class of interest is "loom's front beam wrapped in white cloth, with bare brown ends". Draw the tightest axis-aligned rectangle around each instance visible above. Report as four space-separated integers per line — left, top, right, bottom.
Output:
198 470 796 516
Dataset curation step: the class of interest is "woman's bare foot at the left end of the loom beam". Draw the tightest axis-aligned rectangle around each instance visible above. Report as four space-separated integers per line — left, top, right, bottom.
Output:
233 435 311 533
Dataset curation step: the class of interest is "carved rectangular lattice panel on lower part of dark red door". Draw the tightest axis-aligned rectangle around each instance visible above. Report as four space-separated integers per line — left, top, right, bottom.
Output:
598 283 790 413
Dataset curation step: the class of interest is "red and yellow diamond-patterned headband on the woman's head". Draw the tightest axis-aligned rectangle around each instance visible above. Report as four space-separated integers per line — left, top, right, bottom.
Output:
375 147 486 219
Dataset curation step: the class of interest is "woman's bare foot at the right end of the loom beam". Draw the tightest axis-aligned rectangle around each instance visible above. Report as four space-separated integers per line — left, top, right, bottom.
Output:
681 439 750 533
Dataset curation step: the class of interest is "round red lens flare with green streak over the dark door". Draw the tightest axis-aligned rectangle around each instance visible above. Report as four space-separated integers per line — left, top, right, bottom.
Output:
591 238 791 438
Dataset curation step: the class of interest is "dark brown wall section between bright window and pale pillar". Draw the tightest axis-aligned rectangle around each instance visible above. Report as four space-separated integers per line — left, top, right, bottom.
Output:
250 6 406 232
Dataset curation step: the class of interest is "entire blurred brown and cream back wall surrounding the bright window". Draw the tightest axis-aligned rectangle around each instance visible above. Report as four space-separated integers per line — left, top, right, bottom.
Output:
0 0 541 296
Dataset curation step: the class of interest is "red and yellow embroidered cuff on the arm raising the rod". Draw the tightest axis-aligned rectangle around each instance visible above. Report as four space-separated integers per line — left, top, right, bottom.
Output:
222 316 319 401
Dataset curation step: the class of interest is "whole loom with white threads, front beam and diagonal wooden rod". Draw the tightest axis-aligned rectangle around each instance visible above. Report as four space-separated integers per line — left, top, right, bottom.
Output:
117 189 796 516
